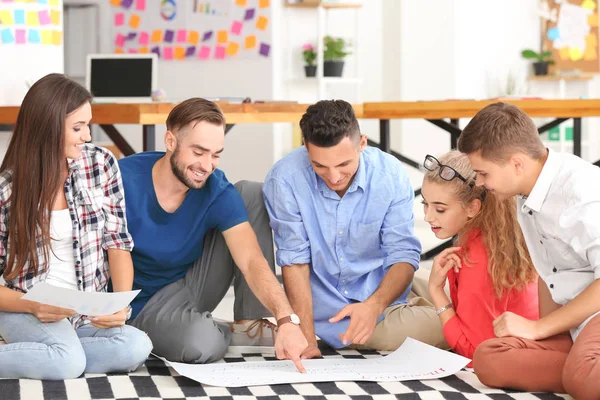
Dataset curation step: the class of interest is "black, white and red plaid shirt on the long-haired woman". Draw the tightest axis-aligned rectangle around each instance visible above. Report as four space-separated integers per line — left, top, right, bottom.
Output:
0 144 133 328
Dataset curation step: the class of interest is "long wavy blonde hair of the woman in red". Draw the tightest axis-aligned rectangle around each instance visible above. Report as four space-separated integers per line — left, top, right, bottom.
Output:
425 151 537 298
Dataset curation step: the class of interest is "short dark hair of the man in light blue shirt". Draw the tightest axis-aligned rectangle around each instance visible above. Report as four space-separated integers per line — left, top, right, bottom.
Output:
300 100 360 147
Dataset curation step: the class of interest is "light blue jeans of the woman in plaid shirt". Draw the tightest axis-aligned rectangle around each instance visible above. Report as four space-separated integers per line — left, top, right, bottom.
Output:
0 312 152 380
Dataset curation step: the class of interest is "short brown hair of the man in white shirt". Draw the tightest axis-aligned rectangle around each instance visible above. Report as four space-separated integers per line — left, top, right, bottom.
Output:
458 102 546 162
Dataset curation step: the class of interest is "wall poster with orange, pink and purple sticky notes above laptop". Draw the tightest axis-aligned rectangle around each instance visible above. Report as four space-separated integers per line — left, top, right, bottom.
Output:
107 0 272 60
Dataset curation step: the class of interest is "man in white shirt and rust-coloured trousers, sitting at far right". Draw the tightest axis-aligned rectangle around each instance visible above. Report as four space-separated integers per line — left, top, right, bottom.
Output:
458 103 600 399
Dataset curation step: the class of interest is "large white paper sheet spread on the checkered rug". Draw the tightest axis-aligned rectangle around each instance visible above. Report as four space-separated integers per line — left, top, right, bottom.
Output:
158 338 471 387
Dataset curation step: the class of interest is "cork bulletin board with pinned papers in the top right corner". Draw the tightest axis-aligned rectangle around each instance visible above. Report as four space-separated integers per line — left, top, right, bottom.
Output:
542 0 600 73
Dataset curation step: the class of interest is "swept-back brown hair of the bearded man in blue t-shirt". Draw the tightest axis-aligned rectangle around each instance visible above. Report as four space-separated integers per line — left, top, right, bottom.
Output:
167 97 225 133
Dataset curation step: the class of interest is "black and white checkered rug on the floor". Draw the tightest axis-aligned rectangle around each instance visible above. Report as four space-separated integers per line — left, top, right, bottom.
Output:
0 348 570 400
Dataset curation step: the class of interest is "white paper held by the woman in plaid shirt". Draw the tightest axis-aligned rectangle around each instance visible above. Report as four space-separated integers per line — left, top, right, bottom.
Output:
23 282 140 317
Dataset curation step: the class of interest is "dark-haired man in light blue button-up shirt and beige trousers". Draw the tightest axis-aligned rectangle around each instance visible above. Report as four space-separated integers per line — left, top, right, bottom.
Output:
263 100 444 358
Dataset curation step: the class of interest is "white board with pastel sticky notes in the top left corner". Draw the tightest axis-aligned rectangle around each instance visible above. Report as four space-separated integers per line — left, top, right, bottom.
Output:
0 0 63 46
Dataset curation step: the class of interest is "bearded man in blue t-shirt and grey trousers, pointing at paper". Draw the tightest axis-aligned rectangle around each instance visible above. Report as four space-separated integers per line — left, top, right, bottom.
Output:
119 98 307 370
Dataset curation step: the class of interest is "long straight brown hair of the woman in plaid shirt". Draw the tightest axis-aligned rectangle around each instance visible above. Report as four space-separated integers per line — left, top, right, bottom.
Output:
0 74 92 279
